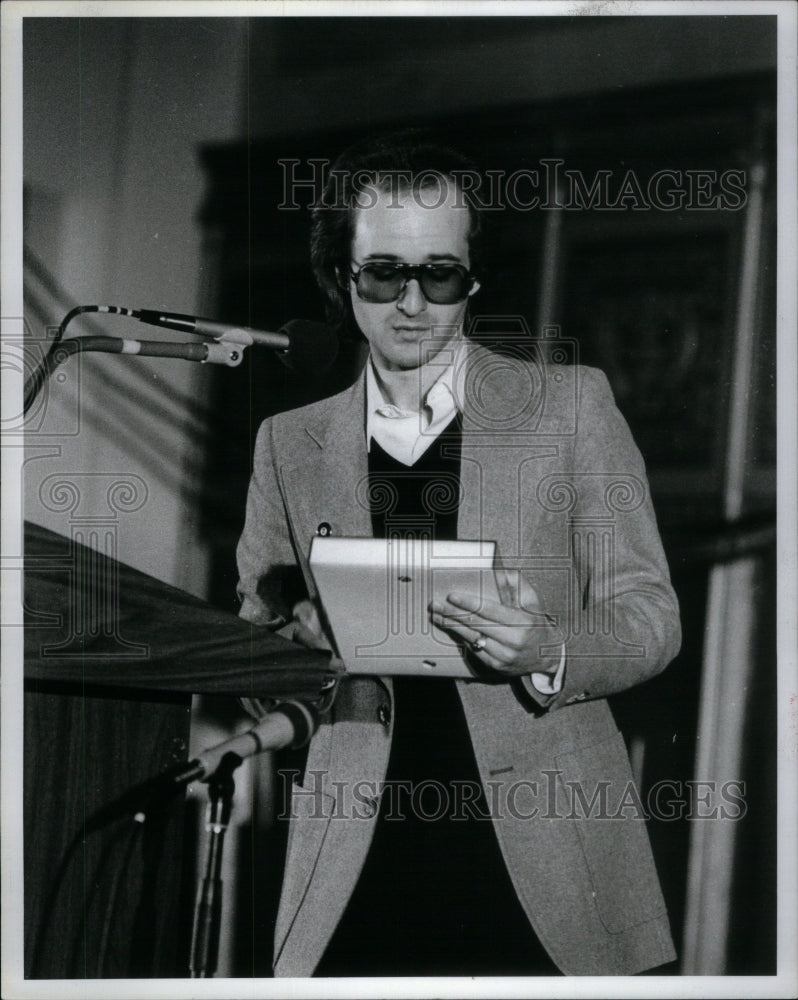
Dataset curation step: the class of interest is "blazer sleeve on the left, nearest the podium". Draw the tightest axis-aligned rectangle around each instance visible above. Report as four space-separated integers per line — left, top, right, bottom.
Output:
236 419 304 629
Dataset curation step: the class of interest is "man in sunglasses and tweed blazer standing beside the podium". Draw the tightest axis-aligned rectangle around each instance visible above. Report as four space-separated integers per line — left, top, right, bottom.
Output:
238 135 680 976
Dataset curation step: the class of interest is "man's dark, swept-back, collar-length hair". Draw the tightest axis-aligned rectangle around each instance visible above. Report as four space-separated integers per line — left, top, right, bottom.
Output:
310 129 484 327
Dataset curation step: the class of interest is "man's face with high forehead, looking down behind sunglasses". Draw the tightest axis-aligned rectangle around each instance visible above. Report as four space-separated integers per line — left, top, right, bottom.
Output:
349 184 479 371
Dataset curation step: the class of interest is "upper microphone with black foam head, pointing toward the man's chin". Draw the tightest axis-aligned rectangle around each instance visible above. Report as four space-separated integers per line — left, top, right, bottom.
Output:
138 309 338 371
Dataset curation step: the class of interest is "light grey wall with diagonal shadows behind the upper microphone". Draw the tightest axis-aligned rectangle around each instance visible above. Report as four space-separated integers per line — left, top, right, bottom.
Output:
23 17 247 594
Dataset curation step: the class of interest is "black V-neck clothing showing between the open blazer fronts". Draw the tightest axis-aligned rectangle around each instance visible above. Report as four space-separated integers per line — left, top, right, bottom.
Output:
316 418 557 976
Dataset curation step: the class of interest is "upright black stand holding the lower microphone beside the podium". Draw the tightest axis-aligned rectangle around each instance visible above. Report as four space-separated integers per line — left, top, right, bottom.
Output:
189 751 242 979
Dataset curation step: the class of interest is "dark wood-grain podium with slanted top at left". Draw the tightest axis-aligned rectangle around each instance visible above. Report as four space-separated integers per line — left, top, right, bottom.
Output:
23 525 337 979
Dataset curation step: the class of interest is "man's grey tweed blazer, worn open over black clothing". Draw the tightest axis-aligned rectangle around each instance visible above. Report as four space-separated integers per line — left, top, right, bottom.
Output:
238 345 681 976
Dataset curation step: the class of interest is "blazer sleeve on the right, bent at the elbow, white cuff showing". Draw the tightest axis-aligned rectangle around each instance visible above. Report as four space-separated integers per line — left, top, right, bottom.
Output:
524 368 681 708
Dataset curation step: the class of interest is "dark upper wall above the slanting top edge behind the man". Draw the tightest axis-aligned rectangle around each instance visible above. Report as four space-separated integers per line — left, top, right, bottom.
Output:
249 17 775 135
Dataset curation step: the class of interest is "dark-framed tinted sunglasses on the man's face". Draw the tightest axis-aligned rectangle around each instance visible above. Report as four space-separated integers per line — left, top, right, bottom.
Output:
350 261 477 306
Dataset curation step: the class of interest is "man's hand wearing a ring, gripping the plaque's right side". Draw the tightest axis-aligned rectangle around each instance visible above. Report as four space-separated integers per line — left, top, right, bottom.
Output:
430 569 562 676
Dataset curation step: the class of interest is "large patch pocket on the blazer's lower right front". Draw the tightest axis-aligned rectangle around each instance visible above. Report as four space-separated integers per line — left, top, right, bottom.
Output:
556 732 665 934
